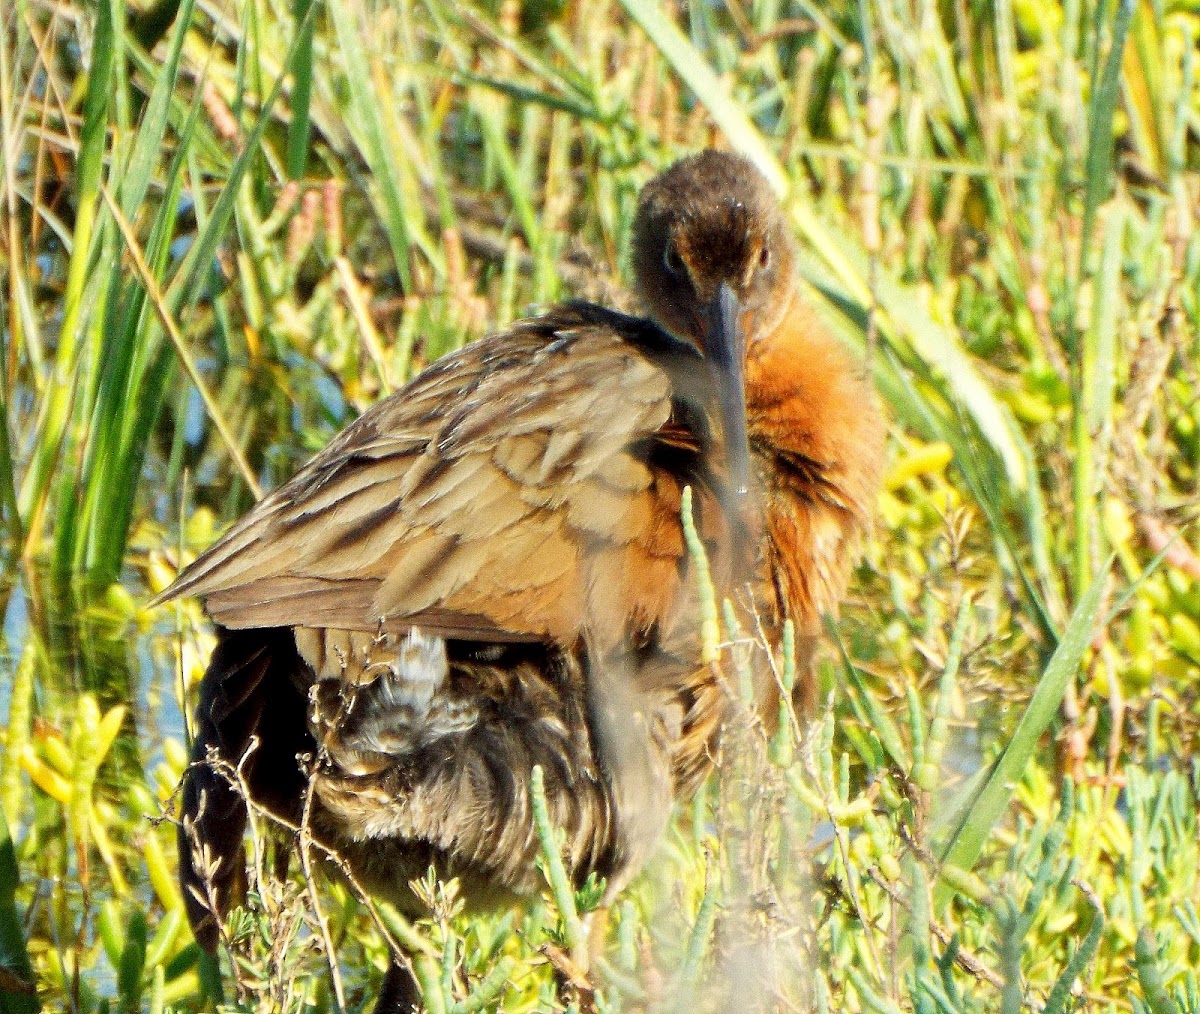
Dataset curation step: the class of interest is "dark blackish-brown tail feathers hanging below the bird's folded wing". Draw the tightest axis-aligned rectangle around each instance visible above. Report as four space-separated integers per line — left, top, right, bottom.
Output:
179 628 313 953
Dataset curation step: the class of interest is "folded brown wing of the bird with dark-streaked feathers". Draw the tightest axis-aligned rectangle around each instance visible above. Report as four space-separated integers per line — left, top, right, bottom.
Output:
162 305 700 643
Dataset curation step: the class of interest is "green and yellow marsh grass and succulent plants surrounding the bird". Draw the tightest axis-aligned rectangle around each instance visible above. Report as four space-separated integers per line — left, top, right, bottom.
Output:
0 0 1200 1014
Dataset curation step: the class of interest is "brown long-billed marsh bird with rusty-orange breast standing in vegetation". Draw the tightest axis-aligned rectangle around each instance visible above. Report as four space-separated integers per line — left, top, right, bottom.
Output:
157 150 884 1009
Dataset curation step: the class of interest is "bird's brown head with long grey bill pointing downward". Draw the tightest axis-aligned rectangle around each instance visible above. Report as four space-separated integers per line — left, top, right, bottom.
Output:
632 151 796 493
